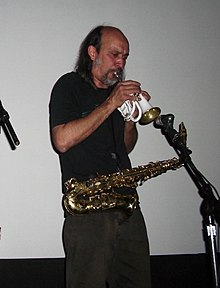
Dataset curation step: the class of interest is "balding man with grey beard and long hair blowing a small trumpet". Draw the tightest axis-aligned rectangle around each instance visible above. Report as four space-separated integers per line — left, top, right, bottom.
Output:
49 26 151 288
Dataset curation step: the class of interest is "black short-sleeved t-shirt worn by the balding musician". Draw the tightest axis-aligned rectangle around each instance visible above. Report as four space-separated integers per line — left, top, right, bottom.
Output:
49 72 136 192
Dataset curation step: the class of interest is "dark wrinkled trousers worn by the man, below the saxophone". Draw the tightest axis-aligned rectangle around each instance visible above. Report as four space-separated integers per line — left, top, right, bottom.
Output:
63 208 151 288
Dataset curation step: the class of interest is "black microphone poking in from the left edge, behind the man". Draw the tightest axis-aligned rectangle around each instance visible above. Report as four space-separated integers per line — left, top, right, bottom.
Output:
0 101 20 150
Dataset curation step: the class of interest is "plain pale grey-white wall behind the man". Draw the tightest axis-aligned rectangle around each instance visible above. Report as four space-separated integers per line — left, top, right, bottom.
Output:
0 0 220 258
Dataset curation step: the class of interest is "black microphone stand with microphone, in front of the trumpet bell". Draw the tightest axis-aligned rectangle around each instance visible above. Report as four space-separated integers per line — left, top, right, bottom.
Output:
155 114 220 288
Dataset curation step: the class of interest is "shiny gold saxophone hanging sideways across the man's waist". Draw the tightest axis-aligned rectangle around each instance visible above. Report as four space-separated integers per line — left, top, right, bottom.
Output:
63 157 183 215
